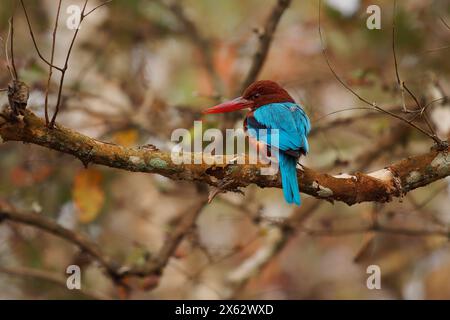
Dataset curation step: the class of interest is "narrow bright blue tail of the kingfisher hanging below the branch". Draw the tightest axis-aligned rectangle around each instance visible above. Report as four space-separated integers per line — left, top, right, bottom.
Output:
279 152 300 206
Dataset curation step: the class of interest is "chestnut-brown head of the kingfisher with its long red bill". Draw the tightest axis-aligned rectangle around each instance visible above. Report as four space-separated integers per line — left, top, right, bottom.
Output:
203 80 295 114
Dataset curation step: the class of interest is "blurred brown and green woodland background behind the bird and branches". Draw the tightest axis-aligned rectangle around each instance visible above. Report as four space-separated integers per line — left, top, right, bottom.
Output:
0 0 450 299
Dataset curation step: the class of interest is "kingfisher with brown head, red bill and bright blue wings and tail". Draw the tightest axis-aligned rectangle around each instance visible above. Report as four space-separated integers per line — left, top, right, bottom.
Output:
203 80 311 205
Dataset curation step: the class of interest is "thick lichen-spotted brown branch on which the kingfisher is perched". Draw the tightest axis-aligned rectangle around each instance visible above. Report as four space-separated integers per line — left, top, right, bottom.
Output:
0 111 450 205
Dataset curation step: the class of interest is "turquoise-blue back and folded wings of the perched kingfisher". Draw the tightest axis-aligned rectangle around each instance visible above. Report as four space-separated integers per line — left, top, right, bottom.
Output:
247 102 311 154
